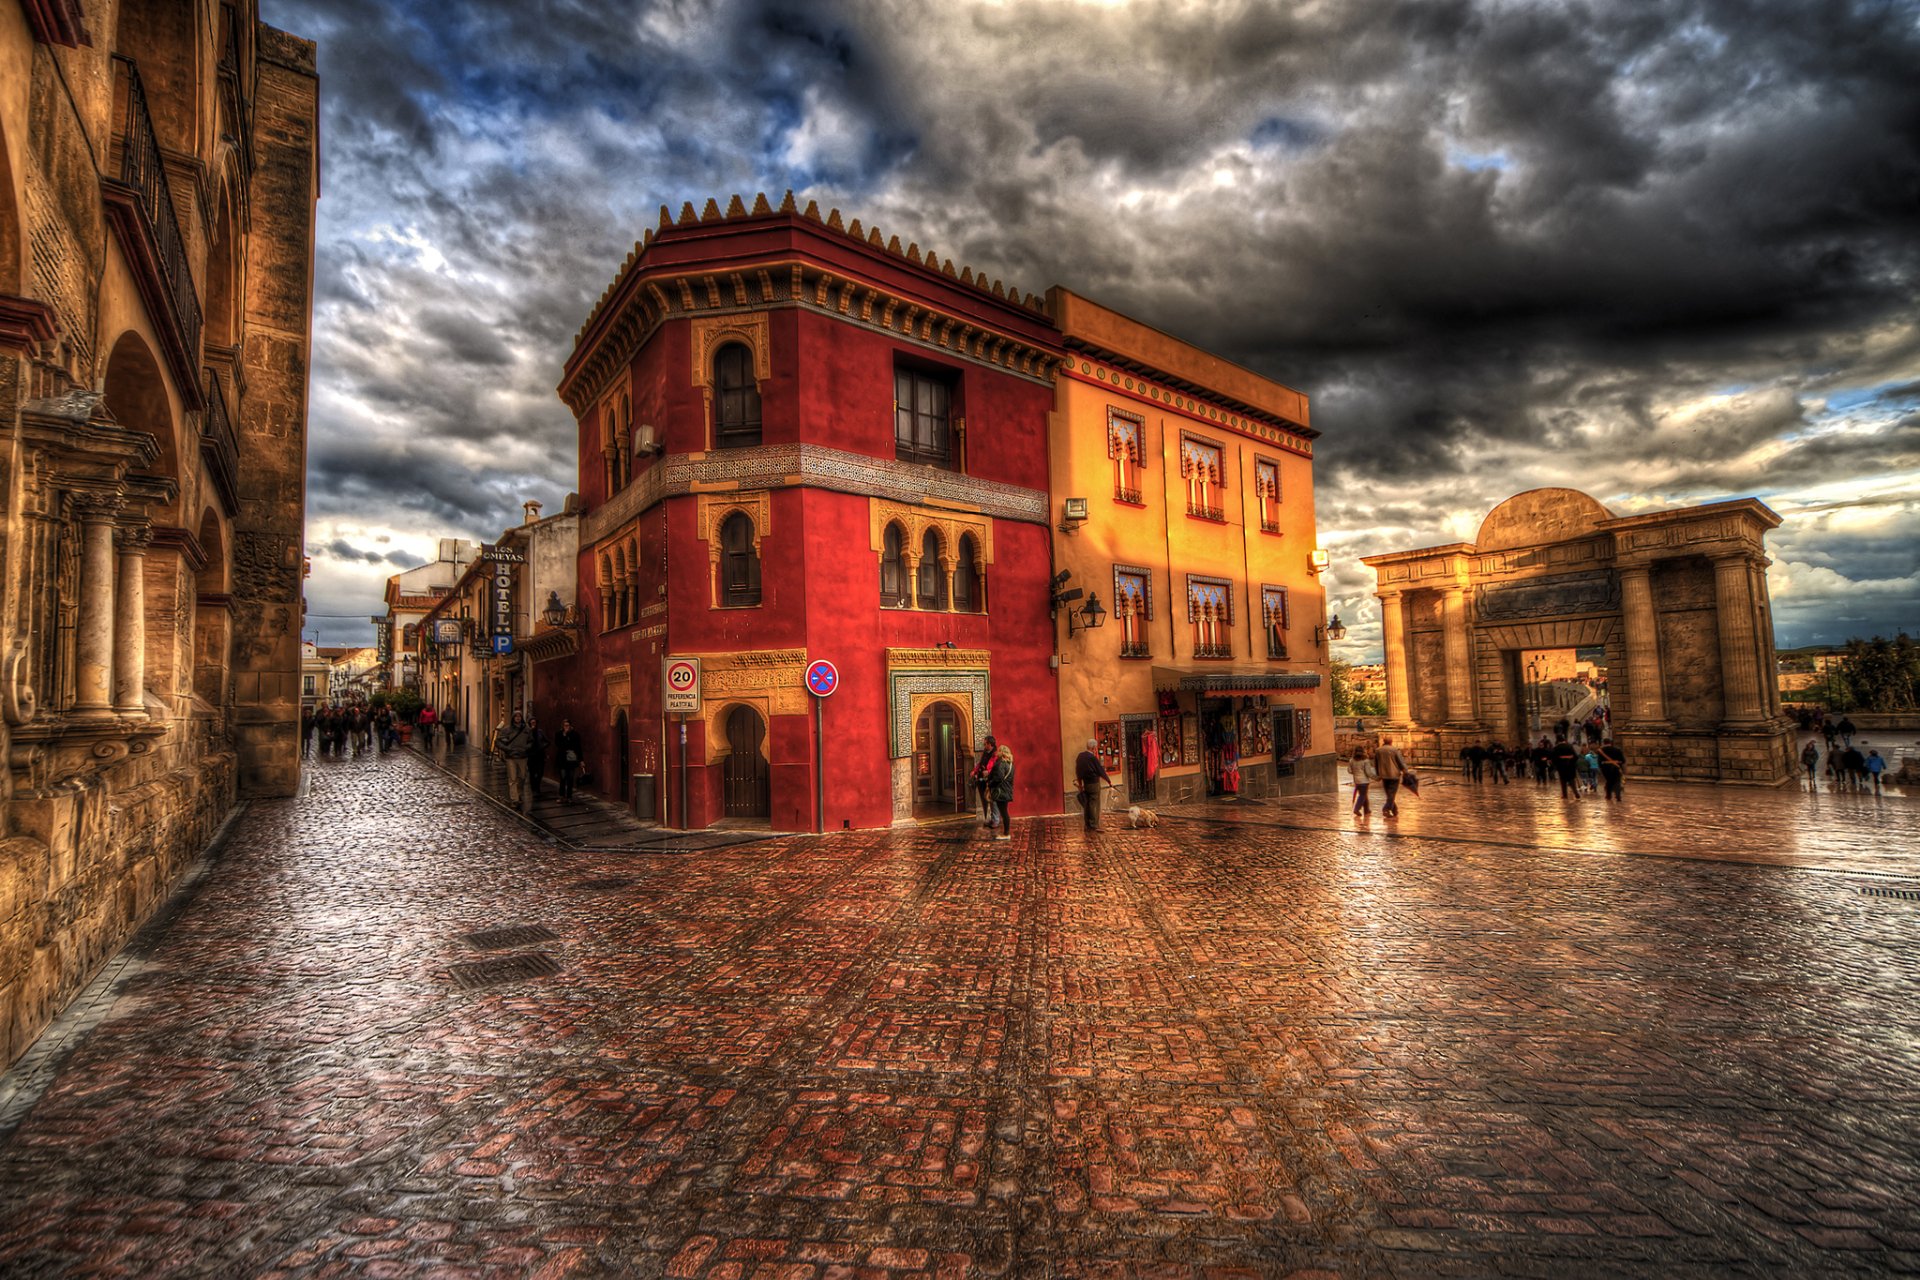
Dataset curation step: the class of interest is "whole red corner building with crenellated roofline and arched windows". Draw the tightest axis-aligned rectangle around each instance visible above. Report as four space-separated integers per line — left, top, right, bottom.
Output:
534 194 1060 831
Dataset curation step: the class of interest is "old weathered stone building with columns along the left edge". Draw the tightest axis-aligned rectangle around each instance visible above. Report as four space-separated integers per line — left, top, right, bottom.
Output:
0 12 315 1065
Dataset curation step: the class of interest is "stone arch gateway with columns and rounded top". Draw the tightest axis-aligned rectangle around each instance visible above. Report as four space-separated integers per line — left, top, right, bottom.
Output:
1363 489 1793 785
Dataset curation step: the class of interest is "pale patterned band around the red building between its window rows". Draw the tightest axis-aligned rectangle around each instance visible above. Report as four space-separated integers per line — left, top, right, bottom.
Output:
580 445 1046 545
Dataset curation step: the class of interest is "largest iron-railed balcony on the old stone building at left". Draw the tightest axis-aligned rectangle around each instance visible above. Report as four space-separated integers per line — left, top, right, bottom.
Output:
100 54 204 411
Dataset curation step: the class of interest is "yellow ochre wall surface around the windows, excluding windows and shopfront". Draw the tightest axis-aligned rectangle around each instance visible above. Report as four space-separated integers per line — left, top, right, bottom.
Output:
1048 290 1334 808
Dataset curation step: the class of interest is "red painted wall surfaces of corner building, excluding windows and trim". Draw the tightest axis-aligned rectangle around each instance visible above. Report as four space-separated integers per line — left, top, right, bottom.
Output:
549 213 1060 831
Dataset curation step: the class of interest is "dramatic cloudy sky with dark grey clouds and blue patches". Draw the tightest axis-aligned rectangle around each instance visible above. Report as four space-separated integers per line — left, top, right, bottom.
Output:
261 0 1920 660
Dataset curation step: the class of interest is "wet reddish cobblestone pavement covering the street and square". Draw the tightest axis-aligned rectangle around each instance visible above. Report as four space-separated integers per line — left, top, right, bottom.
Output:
0 752 1920 1280
